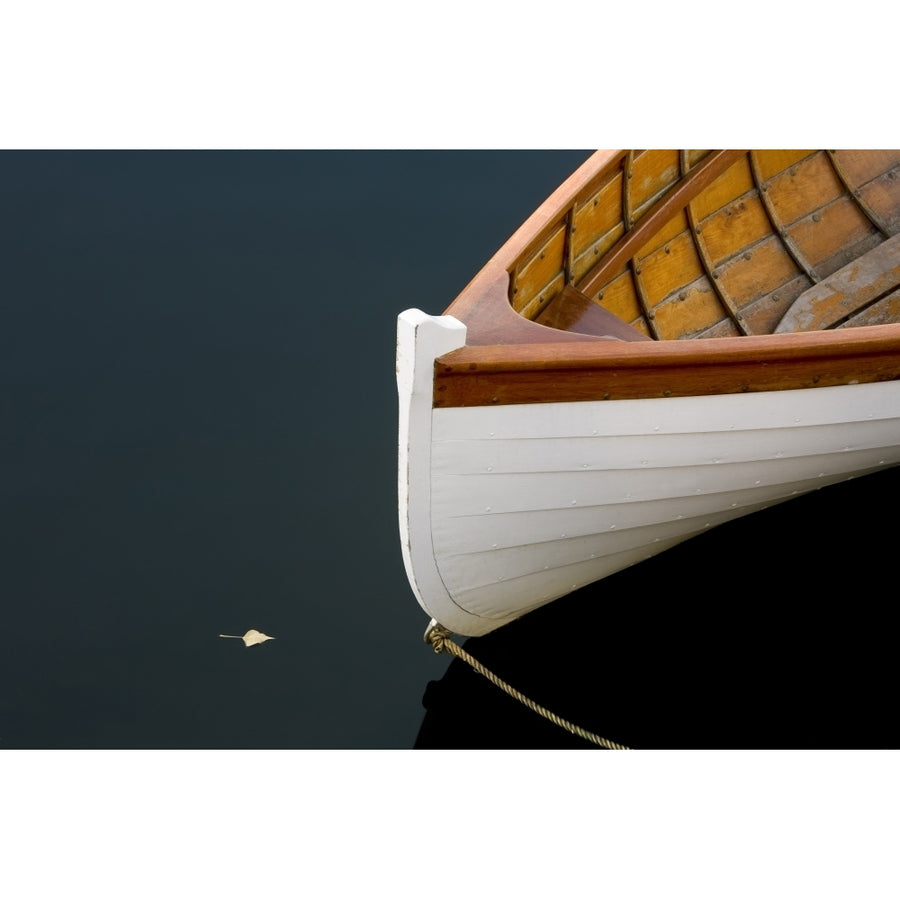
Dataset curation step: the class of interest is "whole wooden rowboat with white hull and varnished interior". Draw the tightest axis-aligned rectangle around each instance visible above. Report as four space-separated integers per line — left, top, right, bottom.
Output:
397 150 900 635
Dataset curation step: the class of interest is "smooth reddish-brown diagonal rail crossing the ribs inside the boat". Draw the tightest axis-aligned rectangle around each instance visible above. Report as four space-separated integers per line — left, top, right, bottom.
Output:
575 150 747 297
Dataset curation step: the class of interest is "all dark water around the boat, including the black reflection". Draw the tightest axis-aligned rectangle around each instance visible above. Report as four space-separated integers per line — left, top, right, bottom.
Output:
0 151 900 749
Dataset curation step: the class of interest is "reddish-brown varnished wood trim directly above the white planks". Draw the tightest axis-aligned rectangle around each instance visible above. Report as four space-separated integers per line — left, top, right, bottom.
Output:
434 325 900 407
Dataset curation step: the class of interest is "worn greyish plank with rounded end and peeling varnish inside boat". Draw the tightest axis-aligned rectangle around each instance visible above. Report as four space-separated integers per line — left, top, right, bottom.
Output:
775 234 900 334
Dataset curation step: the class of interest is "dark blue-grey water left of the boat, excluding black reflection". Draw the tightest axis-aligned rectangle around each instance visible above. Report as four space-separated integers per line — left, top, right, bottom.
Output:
0 151 587 749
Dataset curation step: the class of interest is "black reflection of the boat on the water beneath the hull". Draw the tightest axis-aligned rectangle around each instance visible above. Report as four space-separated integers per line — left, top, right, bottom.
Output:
415 460 900 749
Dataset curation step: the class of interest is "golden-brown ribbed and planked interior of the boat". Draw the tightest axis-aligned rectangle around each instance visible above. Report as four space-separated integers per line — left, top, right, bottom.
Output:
509 150 900 341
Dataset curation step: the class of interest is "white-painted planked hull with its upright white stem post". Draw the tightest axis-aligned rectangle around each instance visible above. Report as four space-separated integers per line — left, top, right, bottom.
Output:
398 310 900 635
